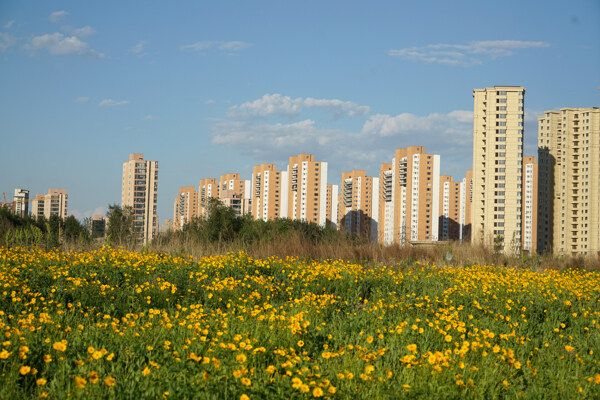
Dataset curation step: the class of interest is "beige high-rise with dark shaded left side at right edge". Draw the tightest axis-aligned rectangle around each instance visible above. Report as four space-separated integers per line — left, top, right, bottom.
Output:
538 107 600 255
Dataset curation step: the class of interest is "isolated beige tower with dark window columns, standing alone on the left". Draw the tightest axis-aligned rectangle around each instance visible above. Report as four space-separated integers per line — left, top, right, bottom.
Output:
121 153 158 244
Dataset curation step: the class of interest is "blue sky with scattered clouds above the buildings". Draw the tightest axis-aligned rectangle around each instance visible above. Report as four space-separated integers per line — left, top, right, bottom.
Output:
0 0 600 221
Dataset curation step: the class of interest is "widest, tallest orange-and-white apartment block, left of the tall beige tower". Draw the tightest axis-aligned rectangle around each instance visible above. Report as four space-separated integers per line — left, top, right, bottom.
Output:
379 146 440 245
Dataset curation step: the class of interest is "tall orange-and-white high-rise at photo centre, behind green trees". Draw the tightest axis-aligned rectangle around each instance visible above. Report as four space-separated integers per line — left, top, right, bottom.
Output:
287 154 327 226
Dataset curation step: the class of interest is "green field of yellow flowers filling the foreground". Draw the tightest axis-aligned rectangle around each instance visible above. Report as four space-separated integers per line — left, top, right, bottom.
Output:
0 248 600 399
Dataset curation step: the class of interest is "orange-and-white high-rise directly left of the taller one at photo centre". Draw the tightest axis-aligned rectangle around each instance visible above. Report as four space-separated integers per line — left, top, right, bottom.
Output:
251 164 288 221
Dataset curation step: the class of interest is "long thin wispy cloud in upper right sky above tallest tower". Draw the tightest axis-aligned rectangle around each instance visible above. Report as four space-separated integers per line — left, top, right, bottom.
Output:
388 40 550 67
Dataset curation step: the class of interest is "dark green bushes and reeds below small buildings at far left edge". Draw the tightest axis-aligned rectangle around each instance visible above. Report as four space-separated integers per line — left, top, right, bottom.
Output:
0 207 91 248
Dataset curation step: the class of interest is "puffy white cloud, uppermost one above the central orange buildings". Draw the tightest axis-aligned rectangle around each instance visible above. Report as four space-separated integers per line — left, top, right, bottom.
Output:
229 93 371 118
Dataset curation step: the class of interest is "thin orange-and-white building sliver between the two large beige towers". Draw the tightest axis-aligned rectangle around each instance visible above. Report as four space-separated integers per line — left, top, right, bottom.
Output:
521 156 538 254
